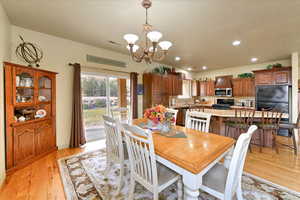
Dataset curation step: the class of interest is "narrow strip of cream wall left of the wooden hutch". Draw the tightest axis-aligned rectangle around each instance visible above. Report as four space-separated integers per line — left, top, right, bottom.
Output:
0 3 11 186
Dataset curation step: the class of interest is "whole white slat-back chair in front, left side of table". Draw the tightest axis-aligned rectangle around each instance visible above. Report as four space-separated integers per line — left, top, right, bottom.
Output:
122 124 182 200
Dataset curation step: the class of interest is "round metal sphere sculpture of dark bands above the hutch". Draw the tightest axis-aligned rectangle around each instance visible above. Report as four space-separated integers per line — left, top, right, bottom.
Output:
16 36 43 67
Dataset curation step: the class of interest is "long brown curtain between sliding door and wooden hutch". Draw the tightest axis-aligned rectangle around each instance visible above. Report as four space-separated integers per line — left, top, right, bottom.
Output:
70 63 86 148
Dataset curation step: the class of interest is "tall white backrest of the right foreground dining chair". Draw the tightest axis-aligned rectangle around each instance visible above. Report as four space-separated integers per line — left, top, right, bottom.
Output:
225 125 257 199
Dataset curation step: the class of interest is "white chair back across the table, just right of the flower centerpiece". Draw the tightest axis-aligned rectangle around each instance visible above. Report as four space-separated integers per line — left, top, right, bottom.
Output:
185 111 211 133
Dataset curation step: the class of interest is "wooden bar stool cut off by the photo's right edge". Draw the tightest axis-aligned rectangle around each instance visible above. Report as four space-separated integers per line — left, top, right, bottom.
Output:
279 113 300 155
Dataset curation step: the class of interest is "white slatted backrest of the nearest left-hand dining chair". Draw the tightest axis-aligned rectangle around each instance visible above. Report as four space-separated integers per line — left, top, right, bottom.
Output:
122 124 158 188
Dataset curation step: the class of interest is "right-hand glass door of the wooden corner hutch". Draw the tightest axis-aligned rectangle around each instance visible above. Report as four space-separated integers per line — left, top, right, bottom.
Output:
37 74 52 103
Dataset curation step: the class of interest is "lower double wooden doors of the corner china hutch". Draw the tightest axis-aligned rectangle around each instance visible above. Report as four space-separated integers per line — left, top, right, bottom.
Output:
13 120 56 169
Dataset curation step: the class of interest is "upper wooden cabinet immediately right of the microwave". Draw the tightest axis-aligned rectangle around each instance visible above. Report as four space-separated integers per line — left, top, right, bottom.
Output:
232 78 255 97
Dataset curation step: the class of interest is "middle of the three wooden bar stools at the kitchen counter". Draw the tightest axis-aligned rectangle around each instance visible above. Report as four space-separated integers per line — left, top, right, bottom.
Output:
256 109 282 153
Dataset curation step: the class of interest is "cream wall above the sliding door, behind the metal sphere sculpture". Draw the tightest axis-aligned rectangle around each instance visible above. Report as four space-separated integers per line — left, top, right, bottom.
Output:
11 26 192 148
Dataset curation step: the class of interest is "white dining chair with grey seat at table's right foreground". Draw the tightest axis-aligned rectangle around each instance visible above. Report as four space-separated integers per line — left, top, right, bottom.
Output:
200 125 257 200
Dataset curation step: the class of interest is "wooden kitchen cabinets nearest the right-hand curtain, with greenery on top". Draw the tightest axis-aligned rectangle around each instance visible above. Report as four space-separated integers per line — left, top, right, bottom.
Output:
143 73 182 110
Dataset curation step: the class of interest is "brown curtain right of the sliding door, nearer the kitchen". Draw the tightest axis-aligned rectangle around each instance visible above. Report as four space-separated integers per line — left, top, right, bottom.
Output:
130 72 138 119
